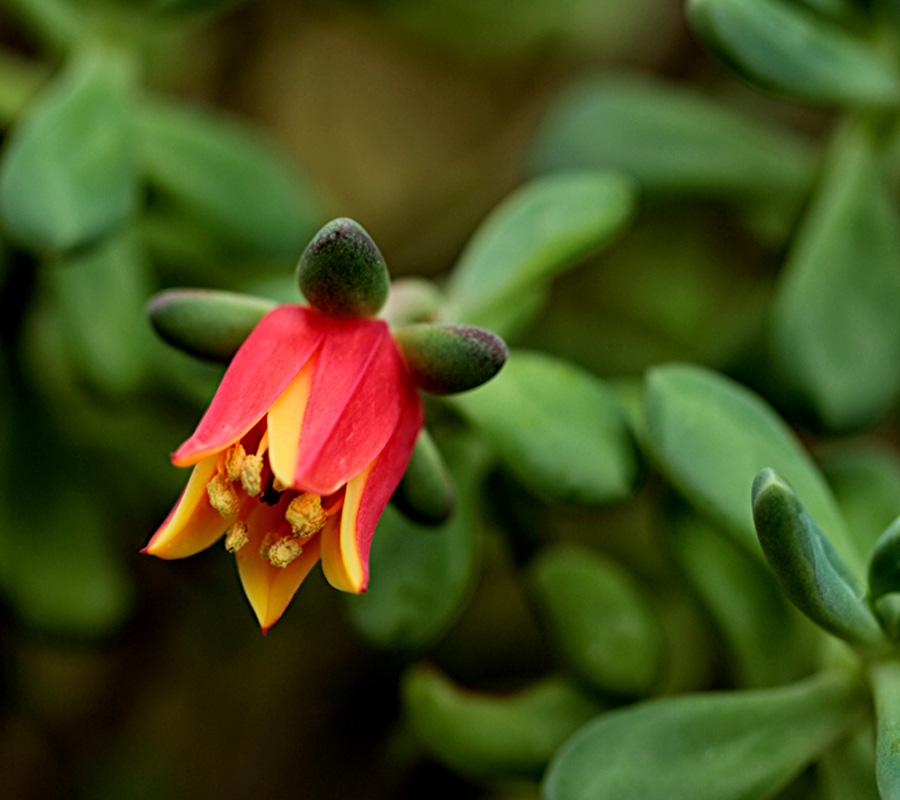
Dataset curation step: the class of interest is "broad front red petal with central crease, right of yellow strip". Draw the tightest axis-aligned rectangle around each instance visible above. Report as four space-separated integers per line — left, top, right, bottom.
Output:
293 320 411 496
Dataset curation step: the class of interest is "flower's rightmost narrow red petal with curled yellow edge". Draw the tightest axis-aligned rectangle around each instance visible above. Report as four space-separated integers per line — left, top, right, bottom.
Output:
321 388 424 594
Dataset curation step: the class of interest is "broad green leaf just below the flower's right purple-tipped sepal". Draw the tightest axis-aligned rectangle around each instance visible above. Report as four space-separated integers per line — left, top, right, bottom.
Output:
446 350 639 504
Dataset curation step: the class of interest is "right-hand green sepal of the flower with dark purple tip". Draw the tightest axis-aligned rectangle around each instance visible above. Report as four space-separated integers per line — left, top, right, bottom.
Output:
393 323 509 394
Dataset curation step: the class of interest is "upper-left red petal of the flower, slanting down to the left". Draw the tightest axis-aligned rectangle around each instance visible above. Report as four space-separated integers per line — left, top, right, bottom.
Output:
172 305 328 467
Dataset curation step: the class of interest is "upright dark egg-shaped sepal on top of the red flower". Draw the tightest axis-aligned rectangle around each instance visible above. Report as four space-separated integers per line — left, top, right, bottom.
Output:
297 217 390 319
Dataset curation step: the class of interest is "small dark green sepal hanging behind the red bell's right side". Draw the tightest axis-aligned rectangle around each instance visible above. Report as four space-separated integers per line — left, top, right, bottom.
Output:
391 428 456 525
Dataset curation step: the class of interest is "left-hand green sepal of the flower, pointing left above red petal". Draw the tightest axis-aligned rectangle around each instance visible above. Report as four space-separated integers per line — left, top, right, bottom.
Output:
147 289 276 361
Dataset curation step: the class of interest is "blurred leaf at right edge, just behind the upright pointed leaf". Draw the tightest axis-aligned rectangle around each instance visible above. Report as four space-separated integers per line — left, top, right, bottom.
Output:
818 439 900 553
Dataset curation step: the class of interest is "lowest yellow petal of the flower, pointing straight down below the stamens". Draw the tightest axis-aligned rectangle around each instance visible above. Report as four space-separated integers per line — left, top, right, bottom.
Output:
234 496 319 633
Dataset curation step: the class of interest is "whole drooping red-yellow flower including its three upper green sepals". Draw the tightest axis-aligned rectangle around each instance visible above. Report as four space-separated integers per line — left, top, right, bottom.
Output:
143 219 507 631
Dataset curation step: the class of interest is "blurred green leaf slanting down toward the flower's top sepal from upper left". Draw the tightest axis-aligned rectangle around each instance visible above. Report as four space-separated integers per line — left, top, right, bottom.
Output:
138 98 321 259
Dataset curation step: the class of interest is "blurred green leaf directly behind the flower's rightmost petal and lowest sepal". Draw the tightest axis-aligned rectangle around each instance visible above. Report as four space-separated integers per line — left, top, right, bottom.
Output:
346 436 487 652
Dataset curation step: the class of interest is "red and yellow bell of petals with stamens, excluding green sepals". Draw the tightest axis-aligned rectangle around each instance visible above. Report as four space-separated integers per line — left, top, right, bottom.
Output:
142 305 423 632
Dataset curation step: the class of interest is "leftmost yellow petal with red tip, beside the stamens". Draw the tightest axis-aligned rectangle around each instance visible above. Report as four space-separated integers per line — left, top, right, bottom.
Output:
142 454 230 558
